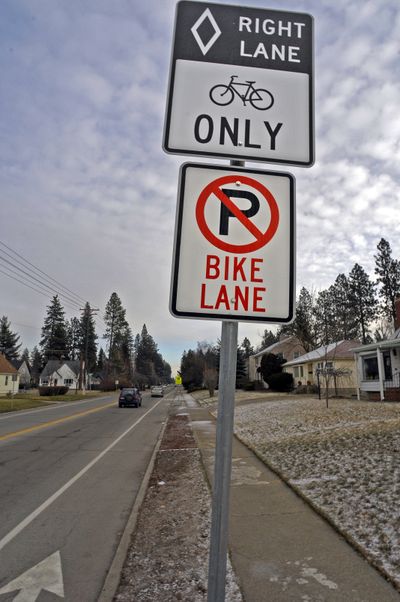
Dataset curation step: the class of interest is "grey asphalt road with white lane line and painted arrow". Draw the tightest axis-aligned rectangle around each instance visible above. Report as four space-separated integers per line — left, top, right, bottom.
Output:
0 394 168 602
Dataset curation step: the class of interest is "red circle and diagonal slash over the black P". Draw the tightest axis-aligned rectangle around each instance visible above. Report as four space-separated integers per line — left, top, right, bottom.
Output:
196 175 279 253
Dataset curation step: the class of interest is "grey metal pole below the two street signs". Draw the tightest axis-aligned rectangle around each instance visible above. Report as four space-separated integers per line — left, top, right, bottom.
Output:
207 322 238 602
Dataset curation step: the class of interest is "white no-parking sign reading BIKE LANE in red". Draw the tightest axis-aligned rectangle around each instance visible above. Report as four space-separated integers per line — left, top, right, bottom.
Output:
170 163 295 323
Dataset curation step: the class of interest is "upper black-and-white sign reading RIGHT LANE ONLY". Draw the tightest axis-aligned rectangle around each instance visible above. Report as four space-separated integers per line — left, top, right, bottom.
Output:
164 0 314 167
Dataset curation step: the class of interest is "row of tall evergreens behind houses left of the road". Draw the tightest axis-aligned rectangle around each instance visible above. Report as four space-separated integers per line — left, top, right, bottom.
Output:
0 292 171 387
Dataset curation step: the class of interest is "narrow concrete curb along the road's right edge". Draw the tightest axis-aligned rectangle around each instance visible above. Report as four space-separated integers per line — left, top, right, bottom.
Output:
97 416 168 602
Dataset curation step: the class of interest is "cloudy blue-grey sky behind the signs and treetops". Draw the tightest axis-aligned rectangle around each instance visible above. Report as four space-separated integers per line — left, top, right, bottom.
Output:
0 0 400 371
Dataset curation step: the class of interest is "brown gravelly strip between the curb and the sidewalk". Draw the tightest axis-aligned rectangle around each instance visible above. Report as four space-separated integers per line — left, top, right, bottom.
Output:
114 399 242 602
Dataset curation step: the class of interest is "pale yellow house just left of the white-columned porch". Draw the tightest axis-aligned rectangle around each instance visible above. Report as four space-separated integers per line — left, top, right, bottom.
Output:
283 340 359 396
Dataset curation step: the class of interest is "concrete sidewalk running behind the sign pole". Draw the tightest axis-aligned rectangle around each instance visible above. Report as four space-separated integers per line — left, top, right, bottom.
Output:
185 395 400 602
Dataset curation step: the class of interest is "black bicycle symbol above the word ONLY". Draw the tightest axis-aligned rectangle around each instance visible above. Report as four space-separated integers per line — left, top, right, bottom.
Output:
210 75 274 111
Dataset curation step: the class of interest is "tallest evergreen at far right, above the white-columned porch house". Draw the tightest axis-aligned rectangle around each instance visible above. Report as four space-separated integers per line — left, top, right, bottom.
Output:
374 238 400 320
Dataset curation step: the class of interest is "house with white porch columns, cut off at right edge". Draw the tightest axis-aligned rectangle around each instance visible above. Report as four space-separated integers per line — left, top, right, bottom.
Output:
353 299 400 401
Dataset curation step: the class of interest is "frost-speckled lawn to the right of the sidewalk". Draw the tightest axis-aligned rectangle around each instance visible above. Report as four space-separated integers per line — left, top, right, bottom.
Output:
235 398 400 585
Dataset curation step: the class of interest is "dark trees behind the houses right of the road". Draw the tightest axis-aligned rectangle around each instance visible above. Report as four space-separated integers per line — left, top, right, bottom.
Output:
181 238 400 388
